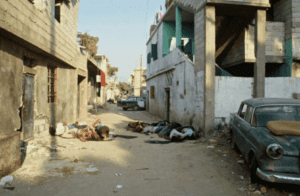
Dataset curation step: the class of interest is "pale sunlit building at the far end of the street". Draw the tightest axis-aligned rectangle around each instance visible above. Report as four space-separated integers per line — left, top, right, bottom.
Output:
129 67 147 97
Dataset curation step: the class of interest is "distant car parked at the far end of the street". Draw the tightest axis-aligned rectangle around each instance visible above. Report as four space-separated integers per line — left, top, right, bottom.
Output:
117 97 146 111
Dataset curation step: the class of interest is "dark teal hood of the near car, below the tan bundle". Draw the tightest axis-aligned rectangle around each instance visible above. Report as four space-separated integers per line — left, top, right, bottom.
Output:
261 127 300 156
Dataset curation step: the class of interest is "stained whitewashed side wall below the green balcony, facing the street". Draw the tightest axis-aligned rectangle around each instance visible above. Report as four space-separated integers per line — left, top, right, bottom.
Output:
147 48 195 125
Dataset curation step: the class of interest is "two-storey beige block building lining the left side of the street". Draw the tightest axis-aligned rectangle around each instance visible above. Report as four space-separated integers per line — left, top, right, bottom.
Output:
0 0 97 176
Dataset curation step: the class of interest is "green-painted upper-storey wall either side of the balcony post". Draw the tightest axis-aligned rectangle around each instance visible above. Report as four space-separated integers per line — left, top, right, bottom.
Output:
162 21 194 61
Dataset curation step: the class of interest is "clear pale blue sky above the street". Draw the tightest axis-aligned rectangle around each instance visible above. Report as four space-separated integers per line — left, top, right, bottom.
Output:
78 0 165 82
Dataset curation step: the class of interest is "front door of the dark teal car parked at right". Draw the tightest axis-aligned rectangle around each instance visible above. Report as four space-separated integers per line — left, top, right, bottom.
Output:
240 105 254 155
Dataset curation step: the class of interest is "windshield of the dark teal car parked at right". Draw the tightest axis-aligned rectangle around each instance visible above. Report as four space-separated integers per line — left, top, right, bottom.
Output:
253 105 300 127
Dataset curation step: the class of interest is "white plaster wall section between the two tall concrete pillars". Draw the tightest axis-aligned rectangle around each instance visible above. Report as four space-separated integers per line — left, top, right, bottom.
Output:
215 76 254 123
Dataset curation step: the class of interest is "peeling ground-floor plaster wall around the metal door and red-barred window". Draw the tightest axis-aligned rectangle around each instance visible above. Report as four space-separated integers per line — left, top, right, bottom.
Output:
0 34 77 137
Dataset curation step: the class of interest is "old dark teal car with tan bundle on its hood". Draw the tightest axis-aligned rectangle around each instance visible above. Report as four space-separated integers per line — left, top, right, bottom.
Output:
229 98 300 184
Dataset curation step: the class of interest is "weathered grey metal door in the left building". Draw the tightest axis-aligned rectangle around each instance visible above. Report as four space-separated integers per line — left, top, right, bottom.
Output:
23 74 34 140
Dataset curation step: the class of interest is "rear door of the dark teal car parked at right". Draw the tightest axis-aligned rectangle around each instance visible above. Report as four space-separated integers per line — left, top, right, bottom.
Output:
232 103 247 150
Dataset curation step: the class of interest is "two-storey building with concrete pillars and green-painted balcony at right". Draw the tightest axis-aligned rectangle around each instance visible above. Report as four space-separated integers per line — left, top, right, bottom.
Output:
147 0 300 135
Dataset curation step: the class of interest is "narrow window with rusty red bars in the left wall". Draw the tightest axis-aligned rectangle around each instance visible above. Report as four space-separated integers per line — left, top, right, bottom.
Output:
48 67 57 103
